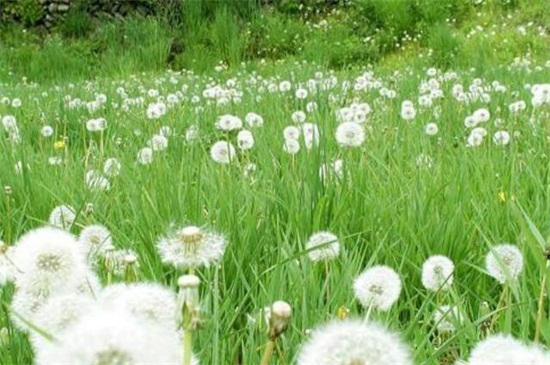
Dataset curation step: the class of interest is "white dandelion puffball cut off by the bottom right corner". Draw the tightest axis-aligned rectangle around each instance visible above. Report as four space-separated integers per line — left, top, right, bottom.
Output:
468 334 550 365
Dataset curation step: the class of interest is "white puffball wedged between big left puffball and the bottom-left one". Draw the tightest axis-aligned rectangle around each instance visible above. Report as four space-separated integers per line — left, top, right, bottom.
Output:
30 293 96 349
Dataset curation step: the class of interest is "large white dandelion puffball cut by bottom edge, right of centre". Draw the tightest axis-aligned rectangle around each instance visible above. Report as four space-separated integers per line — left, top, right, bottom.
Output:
297 320 412 365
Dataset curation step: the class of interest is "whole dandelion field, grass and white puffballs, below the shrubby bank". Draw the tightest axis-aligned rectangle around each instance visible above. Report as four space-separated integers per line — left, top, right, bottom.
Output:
0 54 550 365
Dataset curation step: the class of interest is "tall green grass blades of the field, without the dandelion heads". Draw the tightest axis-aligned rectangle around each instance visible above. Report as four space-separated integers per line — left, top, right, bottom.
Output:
0 57 550 364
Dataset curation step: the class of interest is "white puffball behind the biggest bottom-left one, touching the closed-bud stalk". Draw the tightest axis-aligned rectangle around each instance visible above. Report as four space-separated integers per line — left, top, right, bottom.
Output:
99 283 178 331
